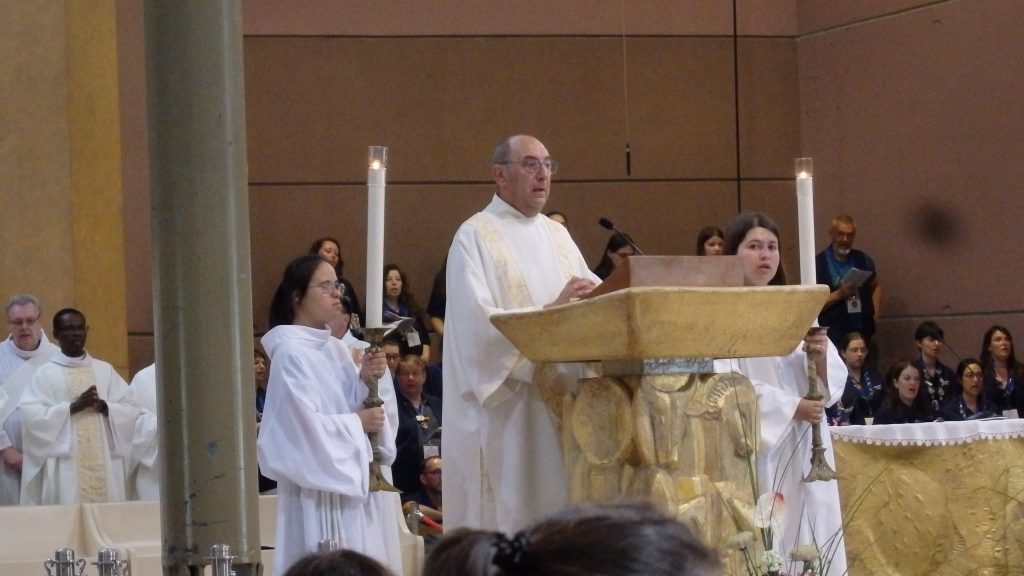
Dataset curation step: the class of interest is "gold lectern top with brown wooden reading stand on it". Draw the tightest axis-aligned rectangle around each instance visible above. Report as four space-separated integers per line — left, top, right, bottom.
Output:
490 256 828 362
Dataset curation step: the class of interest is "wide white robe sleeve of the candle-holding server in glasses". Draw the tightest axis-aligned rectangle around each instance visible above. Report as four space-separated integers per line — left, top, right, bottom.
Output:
256 344 374 497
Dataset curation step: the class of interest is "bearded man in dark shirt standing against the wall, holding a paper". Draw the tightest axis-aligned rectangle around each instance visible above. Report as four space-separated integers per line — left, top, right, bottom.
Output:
815 214 882 350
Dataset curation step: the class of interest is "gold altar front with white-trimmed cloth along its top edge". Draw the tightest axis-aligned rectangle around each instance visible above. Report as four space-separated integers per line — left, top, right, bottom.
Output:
830 419 1024 576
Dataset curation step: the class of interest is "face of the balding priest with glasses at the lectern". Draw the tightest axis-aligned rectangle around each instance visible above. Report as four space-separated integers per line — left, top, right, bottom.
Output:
492 136 551 217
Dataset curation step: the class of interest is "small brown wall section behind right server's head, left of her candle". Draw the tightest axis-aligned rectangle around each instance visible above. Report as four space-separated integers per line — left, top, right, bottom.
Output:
740 180 800 284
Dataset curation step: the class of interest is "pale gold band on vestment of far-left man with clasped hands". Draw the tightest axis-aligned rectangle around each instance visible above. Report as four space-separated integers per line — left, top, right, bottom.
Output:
65 366 110 503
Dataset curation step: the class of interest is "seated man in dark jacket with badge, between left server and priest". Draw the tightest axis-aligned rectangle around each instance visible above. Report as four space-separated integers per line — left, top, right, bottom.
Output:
391 355 441 495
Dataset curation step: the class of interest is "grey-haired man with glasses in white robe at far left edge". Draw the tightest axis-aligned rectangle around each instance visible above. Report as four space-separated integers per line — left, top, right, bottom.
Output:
0 294 58 506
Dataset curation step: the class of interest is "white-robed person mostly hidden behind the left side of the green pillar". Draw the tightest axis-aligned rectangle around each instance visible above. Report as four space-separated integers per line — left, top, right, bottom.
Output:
127 364 160 500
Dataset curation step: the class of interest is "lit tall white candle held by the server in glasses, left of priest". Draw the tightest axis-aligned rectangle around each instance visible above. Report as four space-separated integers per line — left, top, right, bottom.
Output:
366 146 387 328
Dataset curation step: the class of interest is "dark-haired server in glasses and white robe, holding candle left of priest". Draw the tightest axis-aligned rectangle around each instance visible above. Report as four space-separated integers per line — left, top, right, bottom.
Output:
256 255 401 574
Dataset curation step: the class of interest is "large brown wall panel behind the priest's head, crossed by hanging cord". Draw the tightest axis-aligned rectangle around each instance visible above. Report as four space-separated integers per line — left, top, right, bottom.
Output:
246 38 735 182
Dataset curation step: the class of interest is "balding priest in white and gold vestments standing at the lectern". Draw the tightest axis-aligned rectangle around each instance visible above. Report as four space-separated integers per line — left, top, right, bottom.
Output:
442 135 599 532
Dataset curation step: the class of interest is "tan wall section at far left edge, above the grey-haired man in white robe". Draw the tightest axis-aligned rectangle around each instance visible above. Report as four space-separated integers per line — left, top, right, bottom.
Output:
0 2 75 313
